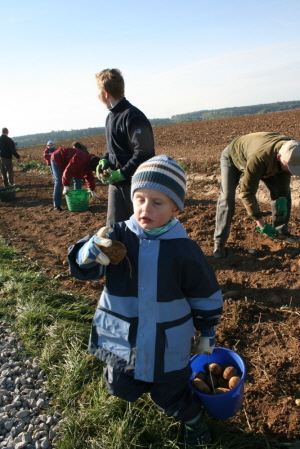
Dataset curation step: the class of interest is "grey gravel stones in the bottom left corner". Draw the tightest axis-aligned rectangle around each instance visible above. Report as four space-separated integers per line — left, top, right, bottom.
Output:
0 321 61 449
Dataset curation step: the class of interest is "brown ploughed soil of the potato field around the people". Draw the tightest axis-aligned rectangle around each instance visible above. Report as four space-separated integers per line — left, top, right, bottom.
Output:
0 110 300 442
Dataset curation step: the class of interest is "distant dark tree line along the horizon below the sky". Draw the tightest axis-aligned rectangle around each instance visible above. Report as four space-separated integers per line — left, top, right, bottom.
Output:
13 101 300 148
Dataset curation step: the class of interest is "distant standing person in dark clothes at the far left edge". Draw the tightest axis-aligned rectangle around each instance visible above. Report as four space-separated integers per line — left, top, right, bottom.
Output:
0 128 21 187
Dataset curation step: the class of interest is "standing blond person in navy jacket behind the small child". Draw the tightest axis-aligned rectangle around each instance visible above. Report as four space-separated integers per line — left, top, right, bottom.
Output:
96 69 155 226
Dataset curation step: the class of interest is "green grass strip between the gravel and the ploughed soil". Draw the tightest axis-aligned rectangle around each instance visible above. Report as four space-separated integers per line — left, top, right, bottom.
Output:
0 240 280 449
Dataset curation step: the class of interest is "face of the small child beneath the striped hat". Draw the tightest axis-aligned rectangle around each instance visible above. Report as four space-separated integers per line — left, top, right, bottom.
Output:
133 187 180 229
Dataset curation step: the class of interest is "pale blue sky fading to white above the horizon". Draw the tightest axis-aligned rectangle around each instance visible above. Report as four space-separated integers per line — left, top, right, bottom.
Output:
0 0 300 137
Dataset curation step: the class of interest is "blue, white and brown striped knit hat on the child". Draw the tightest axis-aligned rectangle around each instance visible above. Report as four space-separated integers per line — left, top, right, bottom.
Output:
131 155 186 211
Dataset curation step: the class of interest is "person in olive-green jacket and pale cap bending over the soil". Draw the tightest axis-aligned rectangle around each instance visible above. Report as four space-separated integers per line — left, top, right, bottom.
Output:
213 132 300 259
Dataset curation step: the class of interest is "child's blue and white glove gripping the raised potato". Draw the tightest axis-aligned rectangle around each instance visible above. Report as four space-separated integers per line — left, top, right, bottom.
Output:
80 226 112 265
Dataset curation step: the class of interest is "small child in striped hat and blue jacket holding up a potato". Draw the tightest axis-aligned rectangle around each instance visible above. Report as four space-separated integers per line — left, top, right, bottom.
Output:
69 155 223 448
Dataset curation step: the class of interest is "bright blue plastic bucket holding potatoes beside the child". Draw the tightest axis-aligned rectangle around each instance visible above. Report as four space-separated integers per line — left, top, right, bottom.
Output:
190 347 246 419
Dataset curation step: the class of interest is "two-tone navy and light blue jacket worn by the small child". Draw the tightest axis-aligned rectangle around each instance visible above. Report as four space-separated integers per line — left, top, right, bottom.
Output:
69 216 223 382
